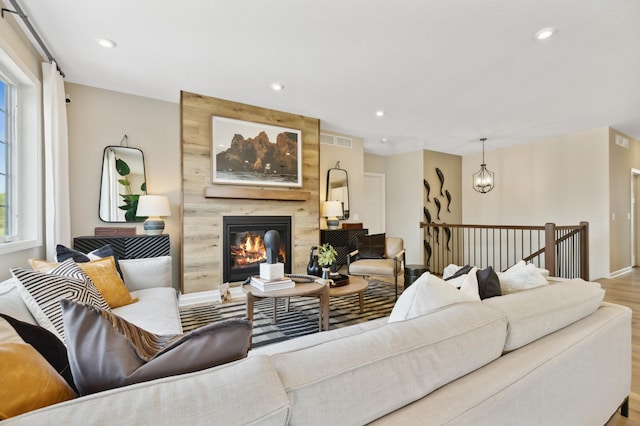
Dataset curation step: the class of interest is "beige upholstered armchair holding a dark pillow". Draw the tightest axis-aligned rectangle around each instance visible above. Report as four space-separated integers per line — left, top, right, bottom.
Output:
347 237 405 299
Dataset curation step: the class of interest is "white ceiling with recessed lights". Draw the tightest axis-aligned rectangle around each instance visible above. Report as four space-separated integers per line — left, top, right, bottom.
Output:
7 0 640 155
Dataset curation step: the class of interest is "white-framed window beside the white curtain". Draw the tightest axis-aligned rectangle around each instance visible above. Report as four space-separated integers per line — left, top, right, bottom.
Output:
0 43 43 254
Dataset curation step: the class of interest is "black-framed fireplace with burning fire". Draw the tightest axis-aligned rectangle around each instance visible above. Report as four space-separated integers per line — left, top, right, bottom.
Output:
222 216 292 282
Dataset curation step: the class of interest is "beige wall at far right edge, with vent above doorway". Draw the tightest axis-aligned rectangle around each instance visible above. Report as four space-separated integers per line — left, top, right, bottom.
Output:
609 129 640 273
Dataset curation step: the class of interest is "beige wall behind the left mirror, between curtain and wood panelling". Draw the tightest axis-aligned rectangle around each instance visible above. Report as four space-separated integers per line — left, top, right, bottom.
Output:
65 83 181 288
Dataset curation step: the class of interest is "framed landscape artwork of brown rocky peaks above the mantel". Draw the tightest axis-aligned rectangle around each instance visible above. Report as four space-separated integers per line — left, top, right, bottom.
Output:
211 116 302 187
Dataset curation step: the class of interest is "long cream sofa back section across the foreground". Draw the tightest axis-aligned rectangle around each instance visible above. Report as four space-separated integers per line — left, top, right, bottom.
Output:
0 266 631 426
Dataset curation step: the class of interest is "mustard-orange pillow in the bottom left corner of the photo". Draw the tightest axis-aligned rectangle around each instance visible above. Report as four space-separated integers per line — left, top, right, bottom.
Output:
0 320 76 419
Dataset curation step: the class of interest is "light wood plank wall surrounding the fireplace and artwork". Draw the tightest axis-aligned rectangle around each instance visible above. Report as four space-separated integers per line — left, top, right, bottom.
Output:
180 92 320 293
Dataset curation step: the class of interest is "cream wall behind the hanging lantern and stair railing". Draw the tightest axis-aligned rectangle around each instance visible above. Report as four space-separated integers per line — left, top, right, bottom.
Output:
462 127 609 280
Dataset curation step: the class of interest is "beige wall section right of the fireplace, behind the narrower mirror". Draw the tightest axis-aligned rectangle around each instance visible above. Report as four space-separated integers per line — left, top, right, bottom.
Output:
320 129 364 229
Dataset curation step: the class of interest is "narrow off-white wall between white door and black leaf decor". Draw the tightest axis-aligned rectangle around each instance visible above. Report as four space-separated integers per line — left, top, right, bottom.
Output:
386 151 424 264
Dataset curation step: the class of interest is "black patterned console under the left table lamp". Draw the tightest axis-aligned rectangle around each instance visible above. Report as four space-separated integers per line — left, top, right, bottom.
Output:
73 234 171 259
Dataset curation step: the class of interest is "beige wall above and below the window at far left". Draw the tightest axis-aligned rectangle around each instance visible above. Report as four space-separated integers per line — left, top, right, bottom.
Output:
0 13 45 280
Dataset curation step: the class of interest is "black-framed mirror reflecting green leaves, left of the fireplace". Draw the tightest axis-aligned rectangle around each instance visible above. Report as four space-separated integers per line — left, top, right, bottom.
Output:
98 145 147 223
